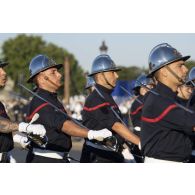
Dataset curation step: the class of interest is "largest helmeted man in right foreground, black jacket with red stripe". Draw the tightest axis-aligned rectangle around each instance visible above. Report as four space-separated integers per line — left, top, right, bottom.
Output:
141 43 195 163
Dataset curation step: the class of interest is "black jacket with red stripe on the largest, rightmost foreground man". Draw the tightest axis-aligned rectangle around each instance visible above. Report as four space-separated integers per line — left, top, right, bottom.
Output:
141 82 195 162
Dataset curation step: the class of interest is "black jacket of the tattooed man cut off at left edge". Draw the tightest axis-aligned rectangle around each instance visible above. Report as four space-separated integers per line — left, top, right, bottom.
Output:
0 102 14 152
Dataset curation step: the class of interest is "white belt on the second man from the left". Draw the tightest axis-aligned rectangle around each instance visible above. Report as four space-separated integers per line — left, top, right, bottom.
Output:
32 148 65 159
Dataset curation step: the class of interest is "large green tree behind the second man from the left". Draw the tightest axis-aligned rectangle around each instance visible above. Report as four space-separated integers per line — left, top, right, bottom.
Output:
1 34 85 95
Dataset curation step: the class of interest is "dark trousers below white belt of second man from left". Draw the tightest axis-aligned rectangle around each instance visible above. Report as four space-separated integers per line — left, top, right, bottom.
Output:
26 152 69 163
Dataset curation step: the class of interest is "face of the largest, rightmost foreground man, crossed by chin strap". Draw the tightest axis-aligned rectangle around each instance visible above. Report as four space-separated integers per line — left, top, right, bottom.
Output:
167 60 188 85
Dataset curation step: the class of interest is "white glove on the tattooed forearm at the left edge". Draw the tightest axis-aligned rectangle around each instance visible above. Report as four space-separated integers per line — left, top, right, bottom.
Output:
18 122 46 137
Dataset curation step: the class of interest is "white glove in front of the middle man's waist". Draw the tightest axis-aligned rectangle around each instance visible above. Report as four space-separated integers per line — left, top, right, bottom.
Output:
87 129 112 141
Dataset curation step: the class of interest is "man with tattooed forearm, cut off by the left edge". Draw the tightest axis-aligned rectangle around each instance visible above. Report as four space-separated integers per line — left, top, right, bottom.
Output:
0 60 45 163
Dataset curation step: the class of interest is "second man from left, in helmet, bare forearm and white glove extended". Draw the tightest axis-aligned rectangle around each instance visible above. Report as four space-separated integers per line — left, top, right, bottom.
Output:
26 55 112 163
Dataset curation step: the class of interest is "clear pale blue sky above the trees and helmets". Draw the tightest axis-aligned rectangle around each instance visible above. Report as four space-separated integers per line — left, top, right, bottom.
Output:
0 33 195 71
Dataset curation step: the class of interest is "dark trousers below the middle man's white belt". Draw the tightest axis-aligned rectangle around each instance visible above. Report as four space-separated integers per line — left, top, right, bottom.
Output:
80 144 124 163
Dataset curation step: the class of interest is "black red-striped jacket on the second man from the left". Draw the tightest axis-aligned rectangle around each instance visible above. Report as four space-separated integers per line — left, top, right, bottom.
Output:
27 89 72 152
